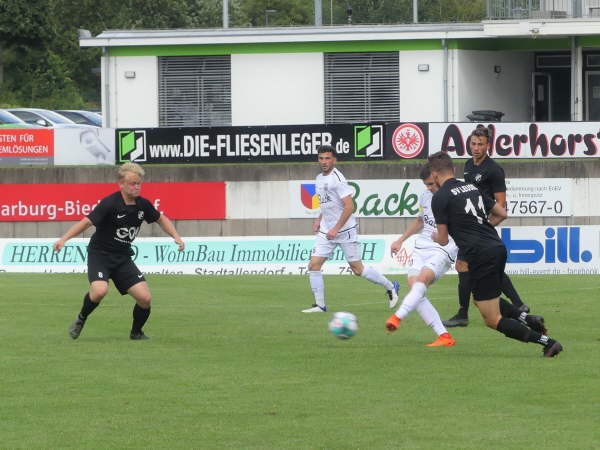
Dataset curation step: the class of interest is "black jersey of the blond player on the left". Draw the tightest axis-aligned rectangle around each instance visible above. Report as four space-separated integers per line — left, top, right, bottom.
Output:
87 191 160 255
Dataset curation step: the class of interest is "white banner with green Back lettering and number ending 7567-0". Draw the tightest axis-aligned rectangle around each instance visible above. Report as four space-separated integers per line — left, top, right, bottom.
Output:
288 178 573 218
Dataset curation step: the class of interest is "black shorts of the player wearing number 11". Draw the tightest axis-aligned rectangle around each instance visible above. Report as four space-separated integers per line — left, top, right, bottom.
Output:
467 245 506 301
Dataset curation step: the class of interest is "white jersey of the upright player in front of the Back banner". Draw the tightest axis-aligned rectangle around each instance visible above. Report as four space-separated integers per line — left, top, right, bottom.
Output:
315 167 356 233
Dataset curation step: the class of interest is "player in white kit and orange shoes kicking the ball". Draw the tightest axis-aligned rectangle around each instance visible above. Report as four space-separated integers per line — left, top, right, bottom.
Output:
385 165 458 347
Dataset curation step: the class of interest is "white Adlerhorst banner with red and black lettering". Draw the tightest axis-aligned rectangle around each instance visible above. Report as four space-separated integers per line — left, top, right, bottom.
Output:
429 122 600 159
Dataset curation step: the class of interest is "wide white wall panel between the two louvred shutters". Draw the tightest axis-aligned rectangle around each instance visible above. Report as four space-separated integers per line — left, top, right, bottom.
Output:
231 53 325 126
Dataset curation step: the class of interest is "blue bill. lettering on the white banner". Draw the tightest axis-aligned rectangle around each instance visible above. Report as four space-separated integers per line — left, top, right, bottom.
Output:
500 227 592 263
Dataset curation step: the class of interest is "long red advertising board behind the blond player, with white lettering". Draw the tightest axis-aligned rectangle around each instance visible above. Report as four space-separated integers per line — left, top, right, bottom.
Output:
0 182 225 222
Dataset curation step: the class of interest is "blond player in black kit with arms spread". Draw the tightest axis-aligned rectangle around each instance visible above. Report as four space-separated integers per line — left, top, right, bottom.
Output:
54 163 184 340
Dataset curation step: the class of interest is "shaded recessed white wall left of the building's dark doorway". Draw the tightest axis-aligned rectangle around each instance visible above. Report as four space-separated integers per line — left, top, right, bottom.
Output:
449 50 533 122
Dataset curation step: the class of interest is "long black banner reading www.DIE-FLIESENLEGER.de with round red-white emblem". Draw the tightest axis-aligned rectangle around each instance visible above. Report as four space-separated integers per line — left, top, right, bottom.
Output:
115 123 428 164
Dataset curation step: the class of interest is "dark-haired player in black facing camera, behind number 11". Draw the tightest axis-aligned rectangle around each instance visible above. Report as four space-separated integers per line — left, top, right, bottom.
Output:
444 125 529 327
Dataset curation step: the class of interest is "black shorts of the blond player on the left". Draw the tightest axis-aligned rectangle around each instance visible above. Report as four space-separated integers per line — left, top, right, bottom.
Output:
88 251 146 295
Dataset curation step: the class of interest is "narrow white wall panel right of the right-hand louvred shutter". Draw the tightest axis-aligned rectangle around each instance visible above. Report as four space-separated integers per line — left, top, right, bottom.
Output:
400 50 444 122
